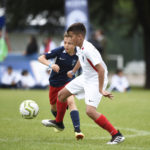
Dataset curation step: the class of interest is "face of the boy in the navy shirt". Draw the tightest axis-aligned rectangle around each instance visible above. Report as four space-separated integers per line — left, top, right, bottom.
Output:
64 37 75 53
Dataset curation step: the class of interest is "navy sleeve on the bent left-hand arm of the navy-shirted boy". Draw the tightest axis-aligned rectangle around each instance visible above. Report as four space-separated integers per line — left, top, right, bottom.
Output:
45 47 64 59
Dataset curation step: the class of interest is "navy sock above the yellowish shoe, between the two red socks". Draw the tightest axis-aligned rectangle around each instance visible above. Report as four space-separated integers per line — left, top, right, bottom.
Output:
70 110 81 132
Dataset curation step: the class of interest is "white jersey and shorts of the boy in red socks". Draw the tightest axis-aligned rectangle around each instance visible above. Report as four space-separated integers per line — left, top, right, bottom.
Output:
66 40 108 107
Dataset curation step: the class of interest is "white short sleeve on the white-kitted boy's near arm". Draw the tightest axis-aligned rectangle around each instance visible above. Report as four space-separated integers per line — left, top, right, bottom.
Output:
85 46 102 66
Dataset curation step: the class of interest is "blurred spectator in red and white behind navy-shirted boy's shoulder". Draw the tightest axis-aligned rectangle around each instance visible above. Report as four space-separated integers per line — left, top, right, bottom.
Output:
40 36 56 54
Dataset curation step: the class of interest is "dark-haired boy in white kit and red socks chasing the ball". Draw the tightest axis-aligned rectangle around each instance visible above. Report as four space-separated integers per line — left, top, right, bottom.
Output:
46 23 125 144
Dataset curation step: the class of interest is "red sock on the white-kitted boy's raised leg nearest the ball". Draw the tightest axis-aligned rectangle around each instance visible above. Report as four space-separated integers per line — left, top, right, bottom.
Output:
56 99 67 122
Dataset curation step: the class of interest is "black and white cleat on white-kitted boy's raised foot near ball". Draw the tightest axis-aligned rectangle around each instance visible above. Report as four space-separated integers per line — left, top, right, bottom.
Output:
42 120 65 131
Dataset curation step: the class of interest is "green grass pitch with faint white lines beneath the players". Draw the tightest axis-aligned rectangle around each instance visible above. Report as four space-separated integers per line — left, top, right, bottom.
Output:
0 88 150 150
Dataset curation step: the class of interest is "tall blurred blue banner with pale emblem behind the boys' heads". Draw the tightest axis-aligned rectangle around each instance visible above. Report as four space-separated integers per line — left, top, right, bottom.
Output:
65 0 89 39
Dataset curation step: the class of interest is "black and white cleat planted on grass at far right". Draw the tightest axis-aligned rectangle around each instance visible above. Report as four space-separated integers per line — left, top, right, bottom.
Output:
107 130 125 145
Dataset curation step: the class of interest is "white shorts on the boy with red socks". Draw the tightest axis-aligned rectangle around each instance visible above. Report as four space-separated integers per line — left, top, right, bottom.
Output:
65 75 108 108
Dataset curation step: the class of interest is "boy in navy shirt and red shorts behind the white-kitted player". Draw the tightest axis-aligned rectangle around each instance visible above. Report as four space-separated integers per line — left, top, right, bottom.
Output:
38 33 84 140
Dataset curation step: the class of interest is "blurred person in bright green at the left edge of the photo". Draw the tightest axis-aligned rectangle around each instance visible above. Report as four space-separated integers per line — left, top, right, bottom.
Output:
0 29 11 62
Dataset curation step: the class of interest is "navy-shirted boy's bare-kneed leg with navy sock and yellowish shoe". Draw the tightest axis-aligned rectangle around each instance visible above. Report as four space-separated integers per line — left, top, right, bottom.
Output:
67 95 84 140
